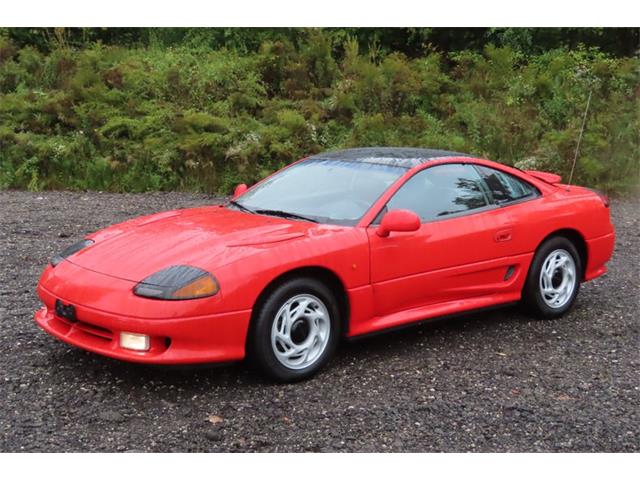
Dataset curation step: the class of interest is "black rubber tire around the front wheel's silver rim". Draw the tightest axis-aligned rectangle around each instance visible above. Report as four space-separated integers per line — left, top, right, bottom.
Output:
247 277 341 382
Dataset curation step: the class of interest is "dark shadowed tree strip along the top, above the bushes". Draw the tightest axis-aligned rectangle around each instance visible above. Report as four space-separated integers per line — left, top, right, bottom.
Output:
0 27 640 57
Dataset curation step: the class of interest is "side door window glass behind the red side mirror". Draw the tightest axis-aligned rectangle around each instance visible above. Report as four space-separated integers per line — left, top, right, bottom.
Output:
386 164 489 222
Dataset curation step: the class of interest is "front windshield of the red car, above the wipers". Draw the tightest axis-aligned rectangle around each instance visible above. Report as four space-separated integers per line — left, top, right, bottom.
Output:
234 159 406 225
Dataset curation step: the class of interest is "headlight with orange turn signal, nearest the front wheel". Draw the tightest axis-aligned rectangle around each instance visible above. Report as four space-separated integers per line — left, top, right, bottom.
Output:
133 265 220 300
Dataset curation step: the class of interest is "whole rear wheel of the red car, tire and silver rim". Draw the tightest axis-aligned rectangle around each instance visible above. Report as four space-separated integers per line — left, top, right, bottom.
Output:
523 237 582 318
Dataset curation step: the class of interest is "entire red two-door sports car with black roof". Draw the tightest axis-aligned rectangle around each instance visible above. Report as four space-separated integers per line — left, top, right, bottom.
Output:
35 148 614 381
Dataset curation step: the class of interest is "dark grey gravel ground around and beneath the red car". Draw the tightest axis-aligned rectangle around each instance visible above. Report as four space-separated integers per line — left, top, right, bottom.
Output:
0 192 640 452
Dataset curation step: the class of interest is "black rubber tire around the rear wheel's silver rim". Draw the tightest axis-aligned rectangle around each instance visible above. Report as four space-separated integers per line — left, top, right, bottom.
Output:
522 236 583 319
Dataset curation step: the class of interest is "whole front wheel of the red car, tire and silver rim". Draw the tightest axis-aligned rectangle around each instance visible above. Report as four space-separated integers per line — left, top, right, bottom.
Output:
249 278 340 382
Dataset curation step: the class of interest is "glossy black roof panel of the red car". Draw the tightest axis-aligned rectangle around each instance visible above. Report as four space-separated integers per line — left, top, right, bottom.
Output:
308 147 471 168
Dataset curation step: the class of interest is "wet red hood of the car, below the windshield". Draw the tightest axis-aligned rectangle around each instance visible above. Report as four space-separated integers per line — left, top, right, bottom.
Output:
67 206 314 282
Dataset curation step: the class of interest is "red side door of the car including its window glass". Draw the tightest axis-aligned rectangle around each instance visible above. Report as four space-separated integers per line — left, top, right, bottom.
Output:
367 164 512 316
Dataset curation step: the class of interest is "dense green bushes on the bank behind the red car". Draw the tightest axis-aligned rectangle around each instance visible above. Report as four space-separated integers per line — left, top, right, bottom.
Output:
0 29 640 192
